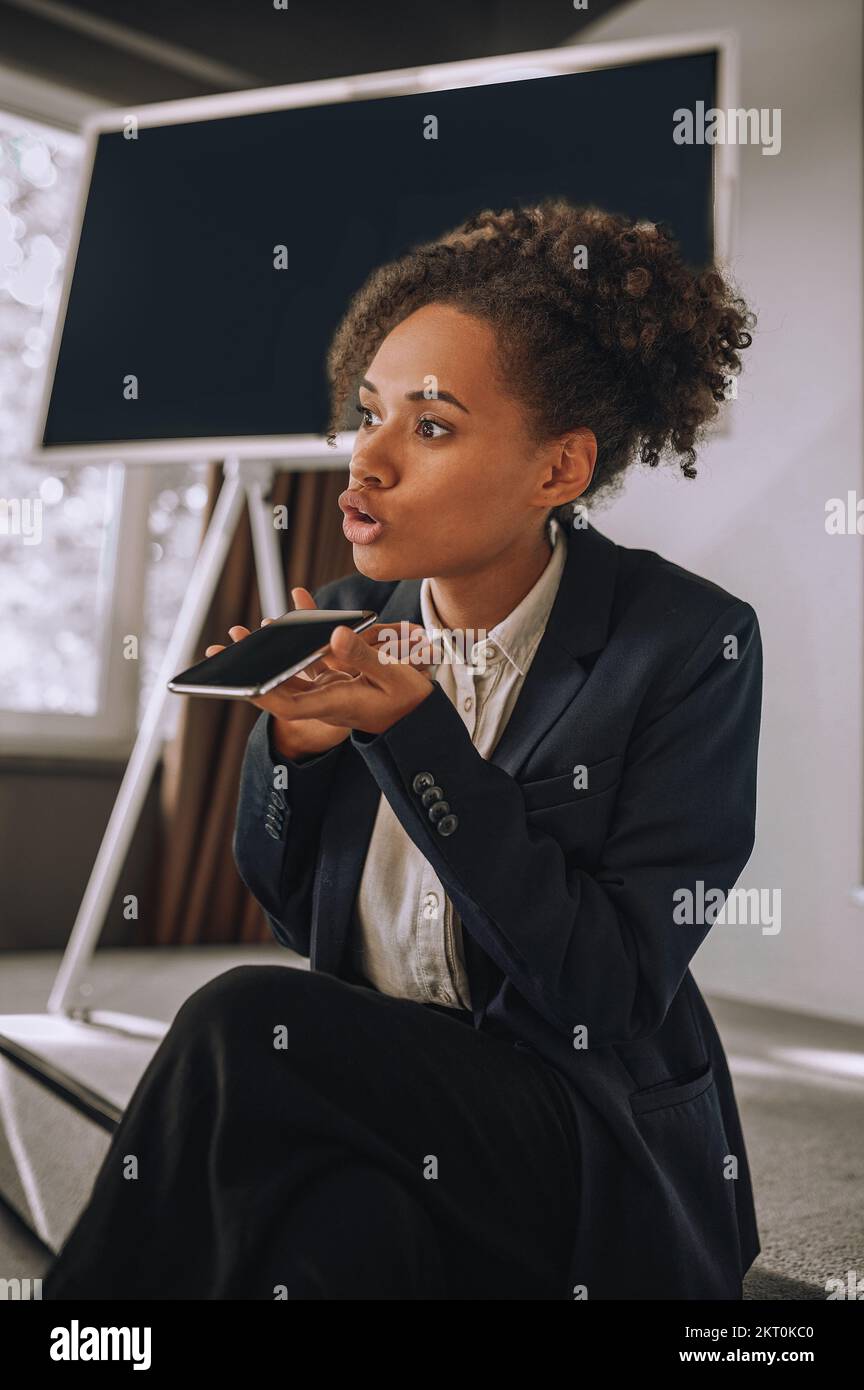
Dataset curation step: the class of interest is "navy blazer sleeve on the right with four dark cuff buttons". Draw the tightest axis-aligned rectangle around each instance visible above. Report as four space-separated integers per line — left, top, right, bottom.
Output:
350 599 761 1047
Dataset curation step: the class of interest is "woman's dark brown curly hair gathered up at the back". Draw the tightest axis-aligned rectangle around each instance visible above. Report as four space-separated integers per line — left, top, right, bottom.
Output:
326 197 756 521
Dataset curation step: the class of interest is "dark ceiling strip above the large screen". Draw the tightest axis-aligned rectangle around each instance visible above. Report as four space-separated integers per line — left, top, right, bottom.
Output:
0 0 636 106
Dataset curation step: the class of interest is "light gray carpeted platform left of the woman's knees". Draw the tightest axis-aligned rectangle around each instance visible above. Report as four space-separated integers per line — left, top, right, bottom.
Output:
0 945 308 1252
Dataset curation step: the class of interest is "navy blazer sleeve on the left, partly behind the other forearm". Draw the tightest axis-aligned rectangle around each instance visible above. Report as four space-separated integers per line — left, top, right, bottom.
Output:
232 580 354 956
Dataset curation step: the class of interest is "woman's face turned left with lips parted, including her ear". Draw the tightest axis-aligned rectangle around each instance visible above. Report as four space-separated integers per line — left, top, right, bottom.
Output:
339 304 593 580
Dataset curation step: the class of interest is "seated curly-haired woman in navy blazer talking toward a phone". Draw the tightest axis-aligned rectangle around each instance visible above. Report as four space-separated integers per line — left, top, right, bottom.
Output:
43 199 761 1300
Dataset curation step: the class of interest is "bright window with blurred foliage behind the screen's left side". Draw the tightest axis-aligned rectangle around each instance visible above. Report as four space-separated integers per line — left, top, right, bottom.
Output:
0 111 213 758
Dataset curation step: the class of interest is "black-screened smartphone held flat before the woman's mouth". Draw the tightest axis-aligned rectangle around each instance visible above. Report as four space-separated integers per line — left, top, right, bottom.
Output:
168 609 378 699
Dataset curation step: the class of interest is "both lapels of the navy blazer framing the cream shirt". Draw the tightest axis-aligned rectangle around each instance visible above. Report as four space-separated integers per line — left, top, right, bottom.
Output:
310 524 618 974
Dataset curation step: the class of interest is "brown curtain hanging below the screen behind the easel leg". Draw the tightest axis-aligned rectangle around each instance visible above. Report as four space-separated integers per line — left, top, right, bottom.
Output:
144 464 354 945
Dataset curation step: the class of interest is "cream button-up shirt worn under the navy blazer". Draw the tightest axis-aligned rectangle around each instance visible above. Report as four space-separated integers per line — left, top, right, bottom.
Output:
351 517 567 1009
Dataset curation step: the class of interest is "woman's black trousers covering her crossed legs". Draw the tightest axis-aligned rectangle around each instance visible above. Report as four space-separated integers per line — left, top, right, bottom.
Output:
43 965 579 1300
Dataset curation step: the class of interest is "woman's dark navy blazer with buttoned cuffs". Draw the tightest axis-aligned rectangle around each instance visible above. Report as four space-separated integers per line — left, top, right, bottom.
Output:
233 524 761 1298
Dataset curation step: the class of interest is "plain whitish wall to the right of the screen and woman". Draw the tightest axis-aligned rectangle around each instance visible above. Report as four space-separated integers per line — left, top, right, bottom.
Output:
569 0 864 1020
